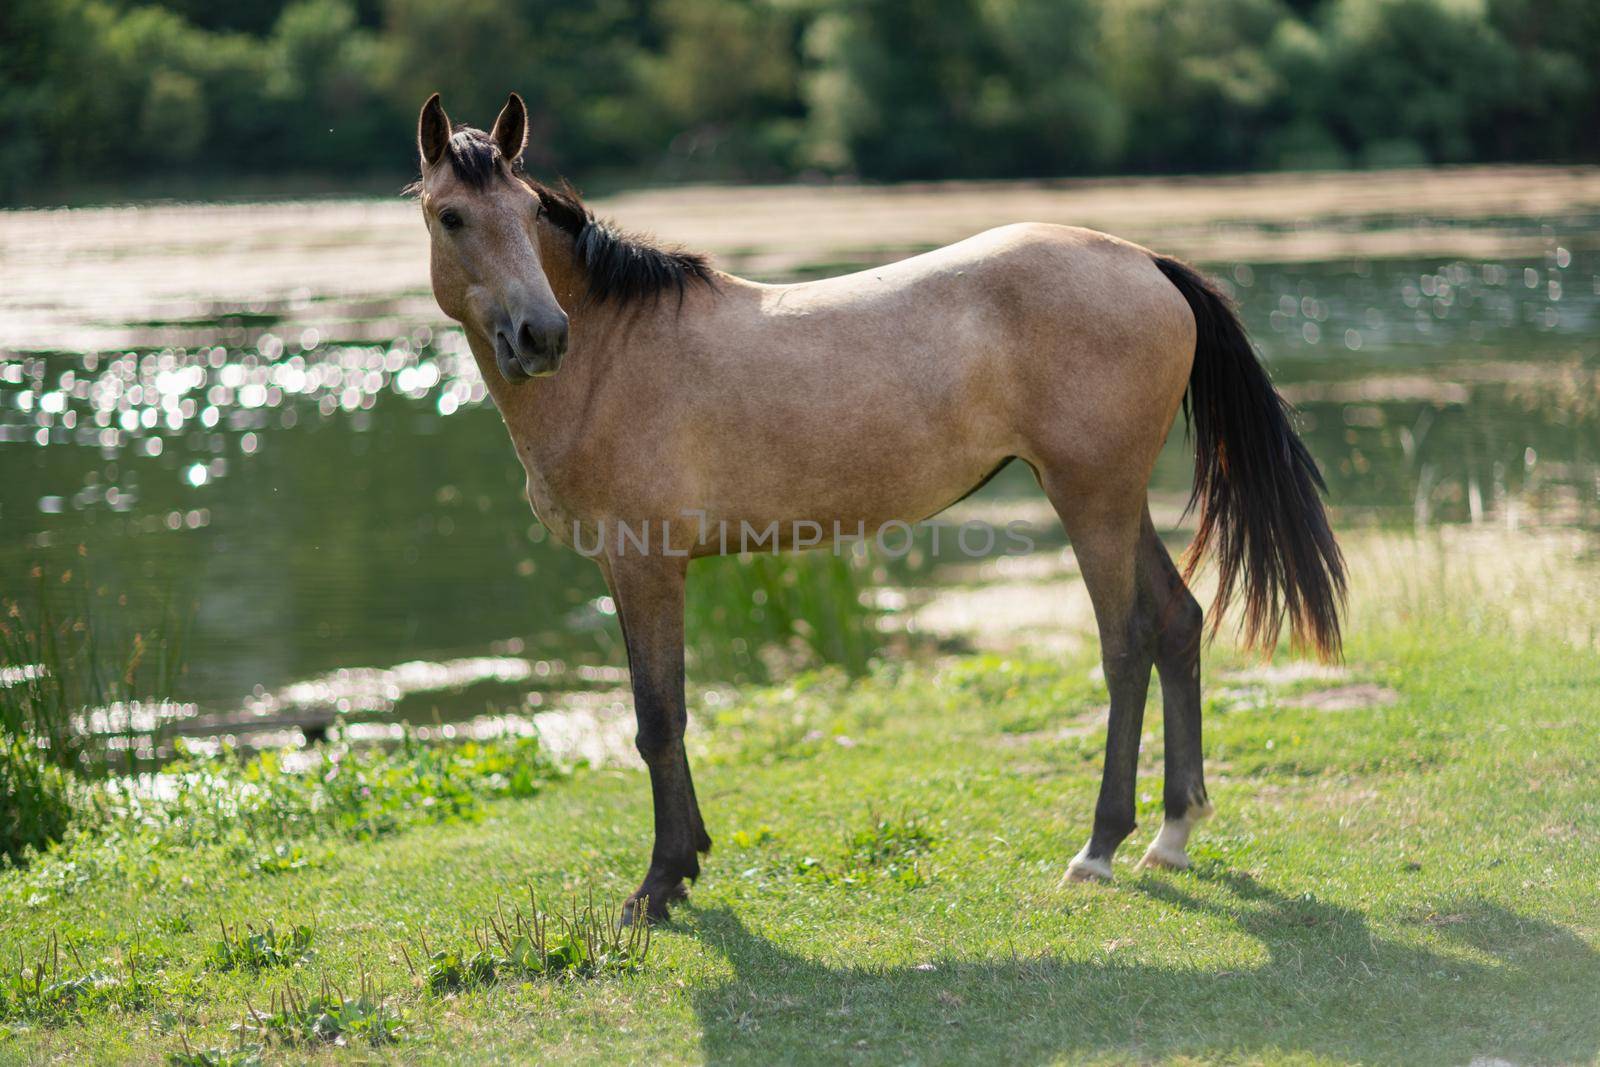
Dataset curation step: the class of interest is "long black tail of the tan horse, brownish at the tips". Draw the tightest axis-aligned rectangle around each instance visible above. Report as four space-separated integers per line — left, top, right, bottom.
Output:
1154 256 1344 659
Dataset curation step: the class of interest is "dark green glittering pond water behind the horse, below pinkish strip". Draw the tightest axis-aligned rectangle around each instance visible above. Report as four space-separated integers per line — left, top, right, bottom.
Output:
0 195 1600 755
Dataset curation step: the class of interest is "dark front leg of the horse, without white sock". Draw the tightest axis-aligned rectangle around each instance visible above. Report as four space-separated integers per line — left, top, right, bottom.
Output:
605 555 710 920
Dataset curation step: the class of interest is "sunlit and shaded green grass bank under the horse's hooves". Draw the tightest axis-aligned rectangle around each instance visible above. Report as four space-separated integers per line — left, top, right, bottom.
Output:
0 531 1600 1064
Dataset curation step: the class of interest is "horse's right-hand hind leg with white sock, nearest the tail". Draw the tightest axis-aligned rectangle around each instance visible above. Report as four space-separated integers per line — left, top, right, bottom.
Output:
1139 515 1211 870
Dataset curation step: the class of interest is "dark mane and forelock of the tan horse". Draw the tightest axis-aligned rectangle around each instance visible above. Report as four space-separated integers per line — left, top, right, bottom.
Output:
408 126 717 304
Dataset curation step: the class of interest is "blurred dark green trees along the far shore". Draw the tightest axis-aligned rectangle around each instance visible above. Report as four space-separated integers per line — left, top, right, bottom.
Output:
0 0 1600 203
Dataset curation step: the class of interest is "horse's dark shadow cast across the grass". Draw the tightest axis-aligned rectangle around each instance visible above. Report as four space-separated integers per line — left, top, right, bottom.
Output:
685 873 1600 1065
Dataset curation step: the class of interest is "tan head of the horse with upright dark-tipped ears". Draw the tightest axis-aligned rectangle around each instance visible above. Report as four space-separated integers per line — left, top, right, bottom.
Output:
416 93 566 382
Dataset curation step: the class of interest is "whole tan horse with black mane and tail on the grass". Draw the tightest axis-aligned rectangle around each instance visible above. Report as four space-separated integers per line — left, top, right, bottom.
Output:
414 94 1344 918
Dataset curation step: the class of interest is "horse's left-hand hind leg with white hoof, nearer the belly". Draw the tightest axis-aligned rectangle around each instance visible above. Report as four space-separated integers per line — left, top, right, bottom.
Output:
1045 486 1157 881
